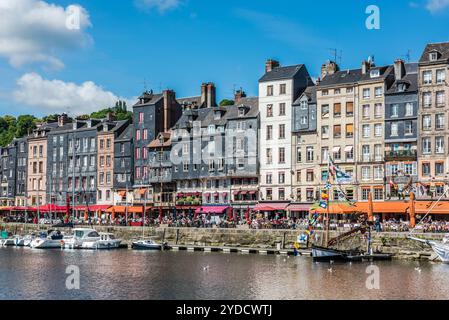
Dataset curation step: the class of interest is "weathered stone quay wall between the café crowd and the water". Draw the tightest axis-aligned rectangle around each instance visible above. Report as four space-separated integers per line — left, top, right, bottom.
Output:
0 224 443 260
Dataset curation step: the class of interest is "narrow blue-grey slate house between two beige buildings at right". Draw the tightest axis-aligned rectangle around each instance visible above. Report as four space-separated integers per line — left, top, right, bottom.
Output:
385 60 418 199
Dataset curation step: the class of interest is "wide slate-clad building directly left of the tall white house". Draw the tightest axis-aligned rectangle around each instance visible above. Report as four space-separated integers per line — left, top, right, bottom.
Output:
172 86 259 219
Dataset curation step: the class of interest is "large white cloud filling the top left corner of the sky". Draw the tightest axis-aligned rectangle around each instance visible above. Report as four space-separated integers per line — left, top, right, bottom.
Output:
0 0 92 69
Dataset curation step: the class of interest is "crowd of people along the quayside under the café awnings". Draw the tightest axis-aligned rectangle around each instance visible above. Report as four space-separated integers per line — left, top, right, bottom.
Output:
2 213 449 233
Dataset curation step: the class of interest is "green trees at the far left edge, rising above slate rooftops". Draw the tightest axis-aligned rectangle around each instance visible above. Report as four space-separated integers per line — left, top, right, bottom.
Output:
0 115 38 147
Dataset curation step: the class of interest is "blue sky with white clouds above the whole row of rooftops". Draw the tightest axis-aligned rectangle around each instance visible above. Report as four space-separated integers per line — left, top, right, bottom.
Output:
0 0 449 117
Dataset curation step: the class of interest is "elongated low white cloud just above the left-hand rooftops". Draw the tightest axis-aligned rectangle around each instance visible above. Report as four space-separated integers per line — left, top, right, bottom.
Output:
13 73 137 115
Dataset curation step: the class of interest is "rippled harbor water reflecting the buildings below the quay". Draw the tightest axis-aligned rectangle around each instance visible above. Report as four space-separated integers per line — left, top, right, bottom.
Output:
0 247 449 300
